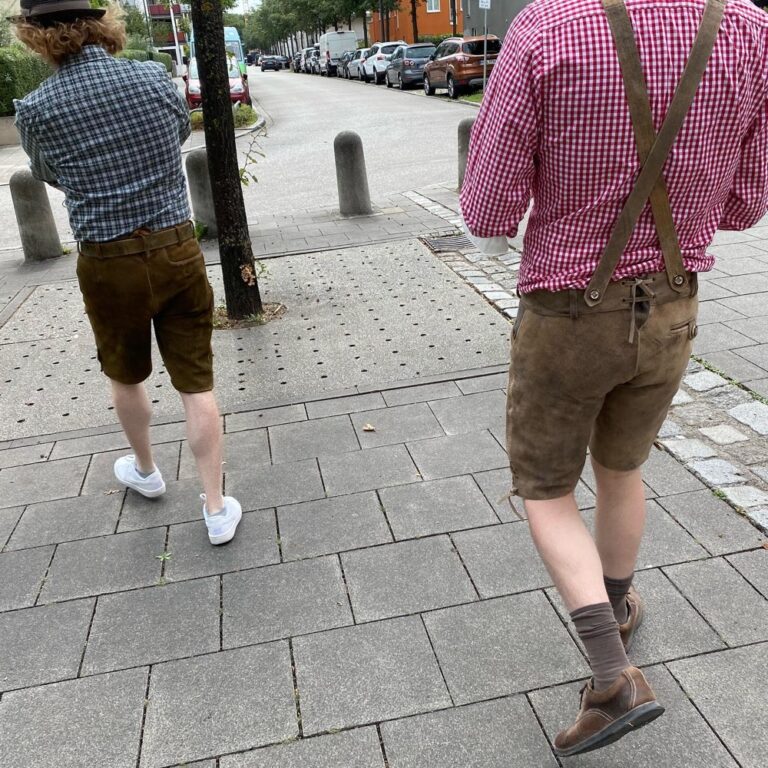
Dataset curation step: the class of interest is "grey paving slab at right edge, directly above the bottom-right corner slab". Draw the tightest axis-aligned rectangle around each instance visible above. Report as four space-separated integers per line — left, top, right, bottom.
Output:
664 558 768 645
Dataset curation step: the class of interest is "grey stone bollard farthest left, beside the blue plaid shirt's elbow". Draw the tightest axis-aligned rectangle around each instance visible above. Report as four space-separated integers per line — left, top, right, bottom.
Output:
9 170 62 261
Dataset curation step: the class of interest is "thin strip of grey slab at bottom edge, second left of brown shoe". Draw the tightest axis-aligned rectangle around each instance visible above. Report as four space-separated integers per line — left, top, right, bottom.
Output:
224 728 384 768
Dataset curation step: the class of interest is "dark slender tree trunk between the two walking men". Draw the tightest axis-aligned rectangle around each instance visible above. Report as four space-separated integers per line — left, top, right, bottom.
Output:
192 0 261 320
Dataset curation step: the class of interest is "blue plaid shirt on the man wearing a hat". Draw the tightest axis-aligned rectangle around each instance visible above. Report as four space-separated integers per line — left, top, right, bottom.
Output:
14 45 190 242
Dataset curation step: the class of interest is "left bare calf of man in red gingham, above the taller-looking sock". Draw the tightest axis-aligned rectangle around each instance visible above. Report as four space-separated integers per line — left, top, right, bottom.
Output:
525 494 608 612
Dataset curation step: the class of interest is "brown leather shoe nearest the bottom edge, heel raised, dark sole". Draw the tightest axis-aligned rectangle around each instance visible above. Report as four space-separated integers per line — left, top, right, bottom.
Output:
554 667 664 757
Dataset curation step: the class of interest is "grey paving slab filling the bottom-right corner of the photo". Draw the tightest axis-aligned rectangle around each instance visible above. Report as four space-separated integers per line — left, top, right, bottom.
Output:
670 643 768 768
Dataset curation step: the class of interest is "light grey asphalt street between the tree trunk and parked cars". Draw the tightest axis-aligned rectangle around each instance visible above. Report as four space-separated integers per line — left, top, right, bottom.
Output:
239 67 477 216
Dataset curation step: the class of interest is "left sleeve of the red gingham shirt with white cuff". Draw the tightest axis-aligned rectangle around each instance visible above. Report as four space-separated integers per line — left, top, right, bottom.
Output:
460 6 538 240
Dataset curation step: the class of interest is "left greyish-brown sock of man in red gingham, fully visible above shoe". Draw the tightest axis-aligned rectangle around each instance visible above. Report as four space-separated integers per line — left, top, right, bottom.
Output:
571 603 631 691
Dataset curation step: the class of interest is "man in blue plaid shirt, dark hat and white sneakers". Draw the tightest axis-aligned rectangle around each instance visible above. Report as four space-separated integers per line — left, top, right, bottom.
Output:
13 0 242 544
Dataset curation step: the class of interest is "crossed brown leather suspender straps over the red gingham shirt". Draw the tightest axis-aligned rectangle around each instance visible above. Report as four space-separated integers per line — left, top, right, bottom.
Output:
584 0 727 307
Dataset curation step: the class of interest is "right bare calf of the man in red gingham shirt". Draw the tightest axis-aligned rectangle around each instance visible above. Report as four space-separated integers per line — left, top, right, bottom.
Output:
592 458 645 579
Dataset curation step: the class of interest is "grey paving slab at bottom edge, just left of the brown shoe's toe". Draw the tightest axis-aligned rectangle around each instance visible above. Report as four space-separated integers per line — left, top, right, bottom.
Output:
381 696 557 768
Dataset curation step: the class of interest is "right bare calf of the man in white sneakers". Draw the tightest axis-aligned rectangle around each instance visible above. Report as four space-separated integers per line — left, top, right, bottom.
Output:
181 392 224 514
